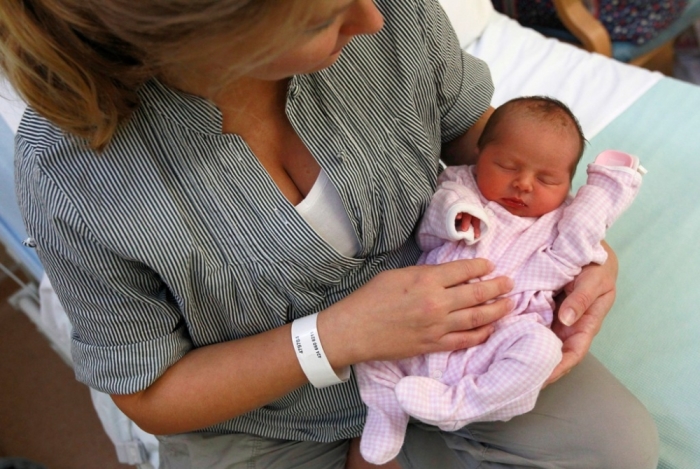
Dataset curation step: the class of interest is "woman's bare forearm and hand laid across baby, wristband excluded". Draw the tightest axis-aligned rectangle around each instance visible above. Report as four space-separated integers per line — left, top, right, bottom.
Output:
112 259 512 434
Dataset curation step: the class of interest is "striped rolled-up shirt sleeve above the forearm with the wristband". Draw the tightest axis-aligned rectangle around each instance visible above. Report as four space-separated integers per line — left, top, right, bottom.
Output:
16 136 192 394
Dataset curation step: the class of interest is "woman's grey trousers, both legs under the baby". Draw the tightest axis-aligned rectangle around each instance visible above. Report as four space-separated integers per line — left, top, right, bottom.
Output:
159 355 658 469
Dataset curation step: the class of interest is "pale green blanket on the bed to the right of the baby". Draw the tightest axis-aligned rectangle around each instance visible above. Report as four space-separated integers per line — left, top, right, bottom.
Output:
574 78 700 469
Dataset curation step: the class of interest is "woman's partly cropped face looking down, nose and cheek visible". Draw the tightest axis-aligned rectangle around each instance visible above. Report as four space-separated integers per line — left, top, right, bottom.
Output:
247 0 384 80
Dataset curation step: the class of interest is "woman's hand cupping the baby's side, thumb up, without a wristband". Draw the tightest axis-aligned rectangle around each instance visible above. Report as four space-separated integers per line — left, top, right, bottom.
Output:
545 243 618 386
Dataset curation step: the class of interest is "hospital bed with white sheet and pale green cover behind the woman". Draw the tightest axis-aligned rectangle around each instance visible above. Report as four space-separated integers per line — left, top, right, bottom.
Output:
0 0 700 469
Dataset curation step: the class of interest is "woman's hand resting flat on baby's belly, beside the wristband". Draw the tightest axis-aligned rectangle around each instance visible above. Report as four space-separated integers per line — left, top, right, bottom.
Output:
318 259 513 368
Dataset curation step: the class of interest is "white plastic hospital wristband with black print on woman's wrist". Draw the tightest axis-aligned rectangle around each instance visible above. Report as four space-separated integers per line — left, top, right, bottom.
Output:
292 313 350 388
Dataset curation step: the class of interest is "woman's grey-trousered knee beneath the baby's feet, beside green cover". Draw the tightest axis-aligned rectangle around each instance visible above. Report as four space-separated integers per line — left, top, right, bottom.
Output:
468 356 658 469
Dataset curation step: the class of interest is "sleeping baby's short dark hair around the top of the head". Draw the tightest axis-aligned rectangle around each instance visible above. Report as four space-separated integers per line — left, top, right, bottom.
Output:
477 96 586 179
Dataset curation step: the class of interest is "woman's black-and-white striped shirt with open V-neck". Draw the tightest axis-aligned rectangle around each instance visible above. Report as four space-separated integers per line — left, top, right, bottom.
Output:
16 0 493 442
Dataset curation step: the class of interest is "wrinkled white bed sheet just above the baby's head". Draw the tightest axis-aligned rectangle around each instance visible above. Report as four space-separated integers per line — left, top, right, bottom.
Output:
464 11 663 140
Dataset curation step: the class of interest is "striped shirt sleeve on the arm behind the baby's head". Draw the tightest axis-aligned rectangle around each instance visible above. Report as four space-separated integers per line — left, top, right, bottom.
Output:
423 0 494 142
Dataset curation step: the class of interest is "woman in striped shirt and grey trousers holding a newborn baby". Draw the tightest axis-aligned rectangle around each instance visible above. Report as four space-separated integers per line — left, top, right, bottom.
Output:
0 0 656 468
